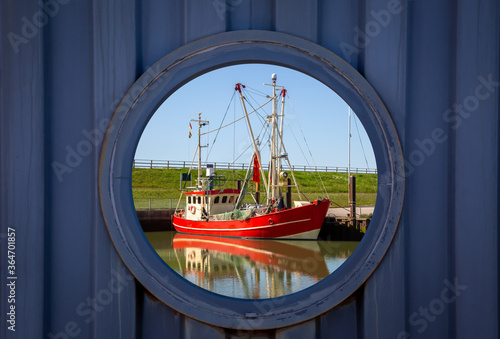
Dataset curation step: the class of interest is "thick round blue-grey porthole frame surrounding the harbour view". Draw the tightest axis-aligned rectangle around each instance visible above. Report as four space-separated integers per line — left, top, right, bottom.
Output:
99 31 404 330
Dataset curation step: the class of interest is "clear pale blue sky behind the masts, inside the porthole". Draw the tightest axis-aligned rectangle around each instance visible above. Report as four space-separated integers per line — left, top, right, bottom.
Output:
135 64 376 168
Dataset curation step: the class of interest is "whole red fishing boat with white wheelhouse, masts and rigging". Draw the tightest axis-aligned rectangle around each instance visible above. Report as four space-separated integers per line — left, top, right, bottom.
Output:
172 74 330 239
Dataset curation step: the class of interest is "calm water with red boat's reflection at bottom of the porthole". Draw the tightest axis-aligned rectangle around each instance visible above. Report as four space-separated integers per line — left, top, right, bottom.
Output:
146 232 359 299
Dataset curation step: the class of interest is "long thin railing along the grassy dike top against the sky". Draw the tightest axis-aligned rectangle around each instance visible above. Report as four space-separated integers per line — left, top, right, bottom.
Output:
133 159 377 174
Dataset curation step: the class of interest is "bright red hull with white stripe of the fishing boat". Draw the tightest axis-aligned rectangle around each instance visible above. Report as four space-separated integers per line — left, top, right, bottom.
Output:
172 199 330 239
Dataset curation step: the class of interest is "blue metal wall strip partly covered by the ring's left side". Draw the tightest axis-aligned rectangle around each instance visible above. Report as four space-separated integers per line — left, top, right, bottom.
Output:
91 0 137 338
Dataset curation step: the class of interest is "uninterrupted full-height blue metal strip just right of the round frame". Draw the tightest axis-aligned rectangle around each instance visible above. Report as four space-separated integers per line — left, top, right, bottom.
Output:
404 2 455 337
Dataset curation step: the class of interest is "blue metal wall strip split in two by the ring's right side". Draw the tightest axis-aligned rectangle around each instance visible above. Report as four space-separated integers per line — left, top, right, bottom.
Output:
362 0 409 338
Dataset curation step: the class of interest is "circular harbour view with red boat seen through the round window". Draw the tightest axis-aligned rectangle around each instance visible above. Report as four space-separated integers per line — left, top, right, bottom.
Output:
132 64 377 299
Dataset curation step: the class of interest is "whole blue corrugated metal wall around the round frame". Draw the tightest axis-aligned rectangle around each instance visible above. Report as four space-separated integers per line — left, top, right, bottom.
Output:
0 0 500 338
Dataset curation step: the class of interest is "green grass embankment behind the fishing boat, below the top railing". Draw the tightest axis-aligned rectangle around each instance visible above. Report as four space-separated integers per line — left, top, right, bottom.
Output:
132 168 377 209
